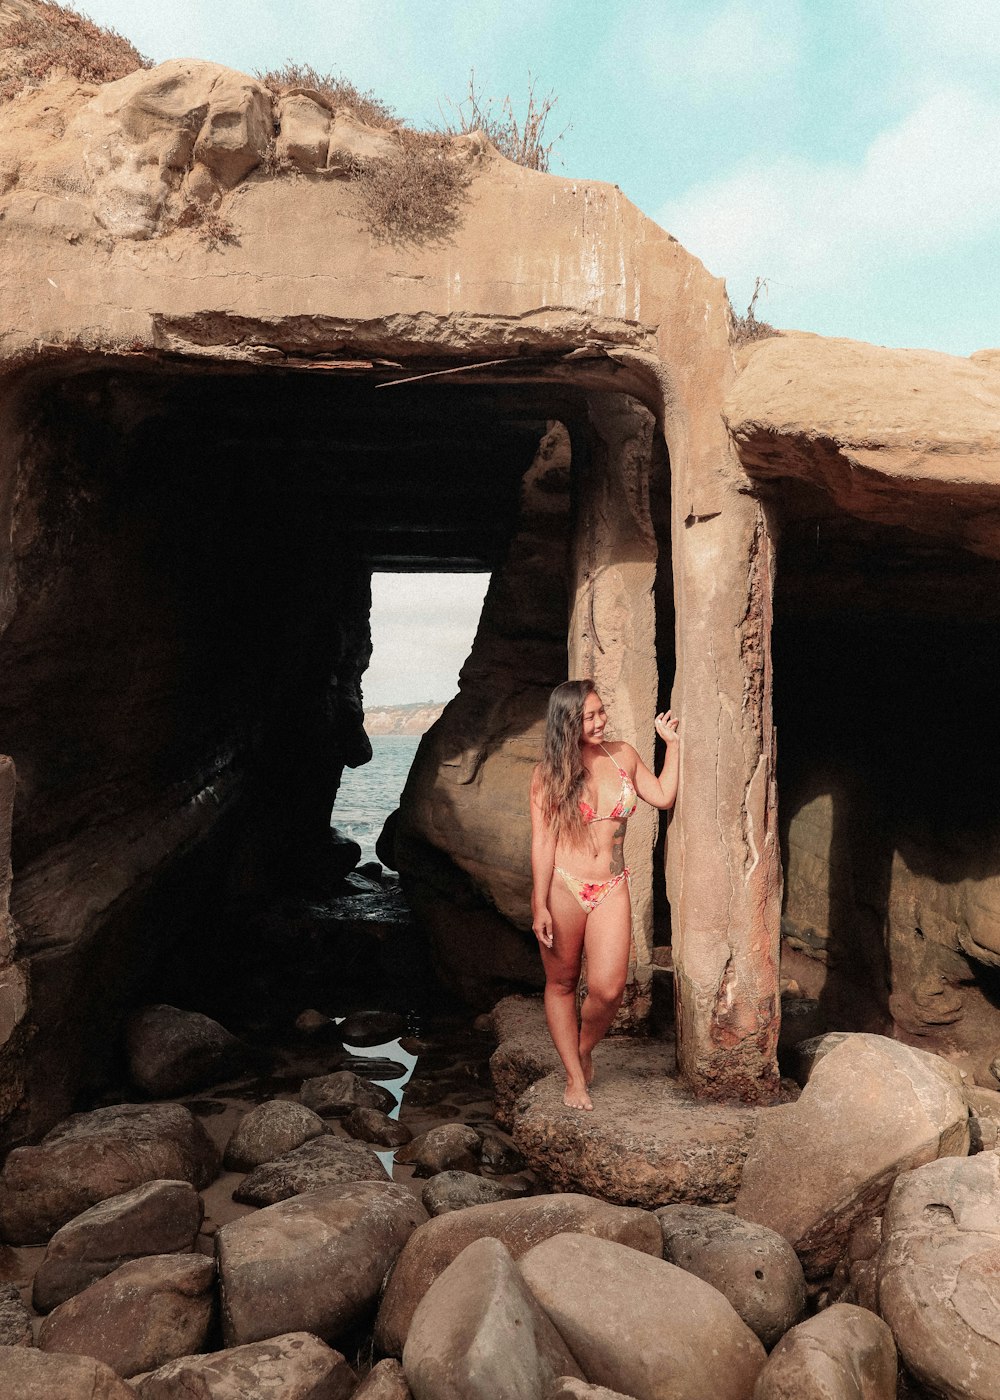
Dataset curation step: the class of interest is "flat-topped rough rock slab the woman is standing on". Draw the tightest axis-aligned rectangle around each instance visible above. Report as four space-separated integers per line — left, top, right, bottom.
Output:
513 1037 763 1208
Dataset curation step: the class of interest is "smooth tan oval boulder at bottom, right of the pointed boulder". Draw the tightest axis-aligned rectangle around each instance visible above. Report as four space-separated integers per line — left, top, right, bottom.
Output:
520 1235 766 1400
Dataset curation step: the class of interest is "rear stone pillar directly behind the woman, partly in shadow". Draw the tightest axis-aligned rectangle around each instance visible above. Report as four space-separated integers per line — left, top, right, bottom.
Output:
569 393 657 1025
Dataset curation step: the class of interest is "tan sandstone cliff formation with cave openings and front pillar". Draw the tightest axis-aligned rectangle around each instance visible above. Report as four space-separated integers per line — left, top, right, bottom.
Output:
0 0 1000 1142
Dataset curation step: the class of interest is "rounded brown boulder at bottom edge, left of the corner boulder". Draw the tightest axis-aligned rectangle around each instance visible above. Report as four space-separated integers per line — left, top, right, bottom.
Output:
754 1303 896 1400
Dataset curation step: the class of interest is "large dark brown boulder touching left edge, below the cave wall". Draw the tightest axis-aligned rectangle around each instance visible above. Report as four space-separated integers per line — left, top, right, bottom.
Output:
0 1103 218 1245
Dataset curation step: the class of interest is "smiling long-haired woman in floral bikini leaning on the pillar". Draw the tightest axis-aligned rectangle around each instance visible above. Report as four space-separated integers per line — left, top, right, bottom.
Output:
531 680 679 1112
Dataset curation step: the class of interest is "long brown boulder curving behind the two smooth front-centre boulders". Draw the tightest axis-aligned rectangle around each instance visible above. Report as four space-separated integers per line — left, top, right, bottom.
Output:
375 1196 662 1357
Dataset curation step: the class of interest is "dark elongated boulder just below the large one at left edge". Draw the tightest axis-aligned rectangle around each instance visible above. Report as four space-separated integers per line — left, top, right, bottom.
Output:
32 1182 203 1312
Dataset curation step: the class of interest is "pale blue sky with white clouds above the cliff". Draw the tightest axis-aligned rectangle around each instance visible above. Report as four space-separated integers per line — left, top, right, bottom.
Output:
70 0 1000 703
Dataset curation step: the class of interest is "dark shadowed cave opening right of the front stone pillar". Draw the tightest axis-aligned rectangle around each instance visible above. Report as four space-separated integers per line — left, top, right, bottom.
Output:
773 483 1000 1086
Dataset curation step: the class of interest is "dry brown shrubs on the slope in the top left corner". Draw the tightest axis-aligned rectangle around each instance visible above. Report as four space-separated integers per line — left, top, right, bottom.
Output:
0 0 151 102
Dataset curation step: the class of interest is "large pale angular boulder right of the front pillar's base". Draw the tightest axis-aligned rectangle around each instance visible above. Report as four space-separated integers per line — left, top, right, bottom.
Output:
737 1035 969 1278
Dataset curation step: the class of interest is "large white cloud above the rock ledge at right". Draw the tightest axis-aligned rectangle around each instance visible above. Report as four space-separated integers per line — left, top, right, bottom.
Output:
657 90 1000 323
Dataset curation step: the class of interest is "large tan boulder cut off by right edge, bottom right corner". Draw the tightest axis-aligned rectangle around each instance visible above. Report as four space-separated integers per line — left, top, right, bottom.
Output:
878 1152 1000 1400
